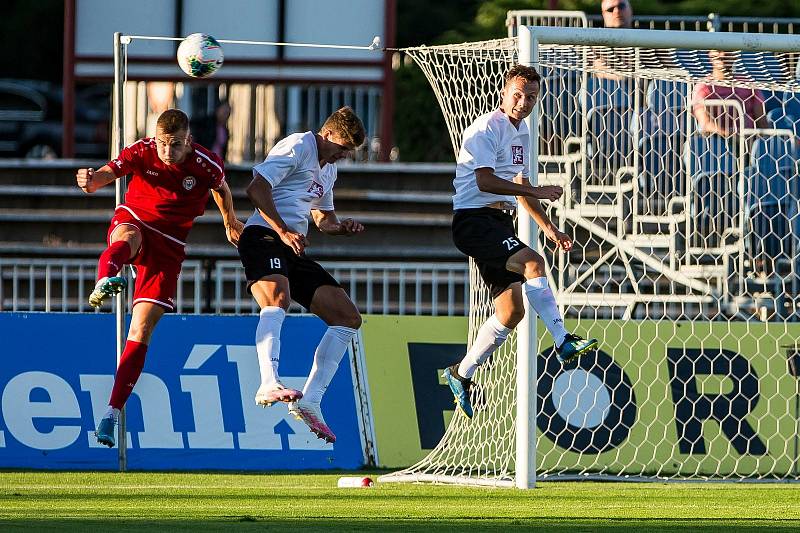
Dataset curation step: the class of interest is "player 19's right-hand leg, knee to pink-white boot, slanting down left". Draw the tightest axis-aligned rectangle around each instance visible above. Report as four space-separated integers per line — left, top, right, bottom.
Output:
289 285 361 442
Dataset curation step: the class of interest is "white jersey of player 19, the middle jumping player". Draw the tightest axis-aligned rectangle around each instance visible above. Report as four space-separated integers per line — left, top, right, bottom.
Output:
246 131 336 235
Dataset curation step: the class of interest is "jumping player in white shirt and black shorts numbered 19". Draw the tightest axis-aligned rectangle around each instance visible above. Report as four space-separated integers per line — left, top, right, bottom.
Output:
234 107 366 442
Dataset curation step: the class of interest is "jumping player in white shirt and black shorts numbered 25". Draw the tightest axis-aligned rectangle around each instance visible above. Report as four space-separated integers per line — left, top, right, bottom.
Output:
444 65 597 418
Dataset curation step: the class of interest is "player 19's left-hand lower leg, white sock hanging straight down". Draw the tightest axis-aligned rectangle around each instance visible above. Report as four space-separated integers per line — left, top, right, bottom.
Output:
250 274 302 407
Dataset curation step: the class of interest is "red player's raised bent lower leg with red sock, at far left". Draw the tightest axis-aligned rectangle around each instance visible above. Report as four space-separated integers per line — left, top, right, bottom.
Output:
89 221 142 307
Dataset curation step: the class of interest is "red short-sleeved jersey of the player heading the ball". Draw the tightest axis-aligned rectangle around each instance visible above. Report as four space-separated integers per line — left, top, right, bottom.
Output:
108 137 225 242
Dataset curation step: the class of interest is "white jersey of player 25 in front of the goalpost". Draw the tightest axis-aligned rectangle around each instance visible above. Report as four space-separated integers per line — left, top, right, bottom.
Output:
453 109 530 209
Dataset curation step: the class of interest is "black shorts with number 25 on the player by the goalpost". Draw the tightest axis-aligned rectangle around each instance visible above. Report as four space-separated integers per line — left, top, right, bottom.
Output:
453 207 527 298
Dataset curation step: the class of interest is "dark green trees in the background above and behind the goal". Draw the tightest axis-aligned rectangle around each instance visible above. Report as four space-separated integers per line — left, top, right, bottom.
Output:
394 0 800 162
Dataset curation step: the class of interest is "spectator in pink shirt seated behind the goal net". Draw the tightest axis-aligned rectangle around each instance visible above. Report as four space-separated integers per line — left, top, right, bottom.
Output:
692 50 768 137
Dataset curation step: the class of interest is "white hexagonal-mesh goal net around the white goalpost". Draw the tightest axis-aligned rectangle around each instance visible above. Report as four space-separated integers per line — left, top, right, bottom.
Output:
381 28 800 486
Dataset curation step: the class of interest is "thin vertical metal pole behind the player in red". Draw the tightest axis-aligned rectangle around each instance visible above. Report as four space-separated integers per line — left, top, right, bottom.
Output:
109 32 128 472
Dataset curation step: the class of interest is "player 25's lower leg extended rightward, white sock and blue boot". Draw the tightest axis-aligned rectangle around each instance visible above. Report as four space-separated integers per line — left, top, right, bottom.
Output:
506 247 597 363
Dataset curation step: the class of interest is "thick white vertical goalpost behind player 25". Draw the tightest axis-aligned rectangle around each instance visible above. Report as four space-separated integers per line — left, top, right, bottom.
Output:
514 26 539 489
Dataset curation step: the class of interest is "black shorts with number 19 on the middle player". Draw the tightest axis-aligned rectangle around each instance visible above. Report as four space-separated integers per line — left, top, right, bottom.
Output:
234 226 341 310
